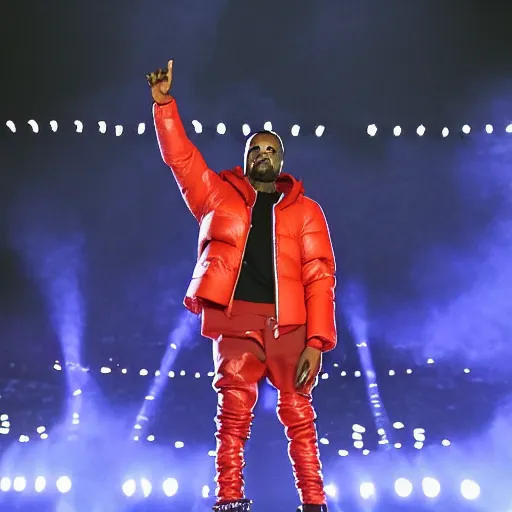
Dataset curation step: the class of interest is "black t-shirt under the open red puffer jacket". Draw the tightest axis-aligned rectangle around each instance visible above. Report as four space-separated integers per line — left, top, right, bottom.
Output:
234 192 281 304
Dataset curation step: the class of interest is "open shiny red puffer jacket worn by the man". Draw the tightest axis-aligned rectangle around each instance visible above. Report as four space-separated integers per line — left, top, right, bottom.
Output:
153 100 336 351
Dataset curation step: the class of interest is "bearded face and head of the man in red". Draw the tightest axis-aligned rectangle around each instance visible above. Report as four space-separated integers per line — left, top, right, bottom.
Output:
245 133 283 183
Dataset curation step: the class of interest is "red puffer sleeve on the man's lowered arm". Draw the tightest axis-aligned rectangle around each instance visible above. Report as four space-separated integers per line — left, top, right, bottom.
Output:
301 199 337 352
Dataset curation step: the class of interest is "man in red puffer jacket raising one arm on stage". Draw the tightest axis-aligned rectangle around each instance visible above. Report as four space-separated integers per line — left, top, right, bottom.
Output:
147 61 336 512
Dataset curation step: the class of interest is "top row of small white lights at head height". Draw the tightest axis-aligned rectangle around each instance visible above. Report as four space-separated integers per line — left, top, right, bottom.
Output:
5 119 512 137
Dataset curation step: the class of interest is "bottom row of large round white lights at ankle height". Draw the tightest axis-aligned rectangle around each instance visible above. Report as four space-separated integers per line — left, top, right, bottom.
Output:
0 476 481 500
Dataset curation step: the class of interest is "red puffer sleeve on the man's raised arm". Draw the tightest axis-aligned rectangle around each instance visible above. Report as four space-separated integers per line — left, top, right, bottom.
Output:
153 100 221 221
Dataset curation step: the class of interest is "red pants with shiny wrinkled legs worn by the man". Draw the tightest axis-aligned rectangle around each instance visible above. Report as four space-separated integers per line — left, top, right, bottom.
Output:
203 301 325 505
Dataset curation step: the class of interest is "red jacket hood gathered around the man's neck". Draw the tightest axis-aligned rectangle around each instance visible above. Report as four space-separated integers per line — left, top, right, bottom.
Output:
219 166 304 208
